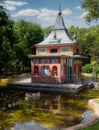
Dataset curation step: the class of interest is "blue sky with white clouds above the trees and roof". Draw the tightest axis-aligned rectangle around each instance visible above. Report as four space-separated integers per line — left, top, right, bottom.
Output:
0 0 93 28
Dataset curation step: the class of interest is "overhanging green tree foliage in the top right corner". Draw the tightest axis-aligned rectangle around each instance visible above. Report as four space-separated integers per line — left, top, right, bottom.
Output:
82 0 99 22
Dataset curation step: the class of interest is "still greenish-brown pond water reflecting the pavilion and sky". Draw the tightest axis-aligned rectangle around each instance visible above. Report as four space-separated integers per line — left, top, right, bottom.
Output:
0 88 99 130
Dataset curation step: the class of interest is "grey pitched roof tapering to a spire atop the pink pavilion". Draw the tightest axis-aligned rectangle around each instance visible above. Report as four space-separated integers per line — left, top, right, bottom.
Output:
36 9 76 46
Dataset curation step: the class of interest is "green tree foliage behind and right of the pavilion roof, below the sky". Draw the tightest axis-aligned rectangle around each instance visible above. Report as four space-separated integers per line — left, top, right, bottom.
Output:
68 26 99 65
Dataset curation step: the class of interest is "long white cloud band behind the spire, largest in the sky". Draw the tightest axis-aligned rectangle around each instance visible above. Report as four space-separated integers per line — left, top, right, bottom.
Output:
12 8 72 22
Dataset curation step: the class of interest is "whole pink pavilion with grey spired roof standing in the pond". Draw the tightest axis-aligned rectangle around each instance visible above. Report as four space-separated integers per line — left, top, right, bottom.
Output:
29 7 81 83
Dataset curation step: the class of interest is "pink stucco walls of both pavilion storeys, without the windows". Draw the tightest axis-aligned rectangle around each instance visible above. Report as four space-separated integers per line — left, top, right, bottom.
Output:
31 44 81 82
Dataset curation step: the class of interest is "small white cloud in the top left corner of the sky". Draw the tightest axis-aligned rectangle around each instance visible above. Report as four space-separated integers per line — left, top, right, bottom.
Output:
4 0 28 11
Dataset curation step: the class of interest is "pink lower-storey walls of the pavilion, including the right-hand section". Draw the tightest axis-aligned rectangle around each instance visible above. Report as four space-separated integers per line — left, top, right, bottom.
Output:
31 59 81 82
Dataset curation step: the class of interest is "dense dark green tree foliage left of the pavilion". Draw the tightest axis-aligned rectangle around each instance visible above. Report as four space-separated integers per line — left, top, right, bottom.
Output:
0 6 43 74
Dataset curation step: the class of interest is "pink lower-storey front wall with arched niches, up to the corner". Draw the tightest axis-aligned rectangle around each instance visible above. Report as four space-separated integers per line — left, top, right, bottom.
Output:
31 59 66 82
